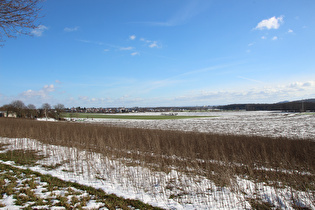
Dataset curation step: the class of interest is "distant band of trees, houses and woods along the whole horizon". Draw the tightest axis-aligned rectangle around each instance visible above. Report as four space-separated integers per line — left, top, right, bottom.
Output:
0 99 315 119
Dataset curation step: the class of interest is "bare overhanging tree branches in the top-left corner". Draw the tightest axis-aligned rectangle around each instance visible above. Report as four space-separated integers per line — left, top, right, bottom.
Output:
0 0 41 41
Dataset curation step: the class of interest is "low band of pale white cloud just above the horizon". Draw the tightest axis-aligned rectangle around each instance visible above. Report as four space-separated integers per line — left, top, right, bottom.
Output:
15 77 315 107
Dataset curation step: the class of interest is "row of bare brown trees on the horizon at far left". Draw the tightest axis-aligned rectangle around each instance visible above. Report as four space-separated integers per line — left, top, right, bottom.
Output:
1 100 65 119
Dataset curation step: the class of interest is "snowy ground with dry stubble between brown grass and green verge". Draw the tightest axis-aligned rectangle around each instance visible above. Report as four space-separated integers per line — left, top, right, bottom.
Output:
0 138 315 209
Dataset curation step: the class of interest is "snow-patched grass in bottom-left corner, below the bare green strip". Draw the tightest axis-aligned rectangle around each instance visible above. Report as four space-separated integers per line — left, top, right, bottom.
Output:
0 163 106 210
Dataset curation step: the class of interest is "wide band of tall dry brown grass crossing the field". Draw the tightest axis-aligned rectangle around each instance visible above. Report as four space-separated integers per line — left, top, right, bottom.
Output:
0 118 315 191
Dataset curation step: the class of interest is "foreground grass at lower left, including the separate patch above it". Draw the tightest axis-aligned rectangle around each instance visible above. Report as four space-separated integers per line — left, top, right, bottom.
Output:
0 150 159 209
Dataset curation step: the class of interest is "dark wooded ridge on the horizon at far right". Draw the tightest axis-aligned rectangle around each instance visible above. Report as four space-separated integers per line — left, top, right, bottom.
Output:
215 99 315 112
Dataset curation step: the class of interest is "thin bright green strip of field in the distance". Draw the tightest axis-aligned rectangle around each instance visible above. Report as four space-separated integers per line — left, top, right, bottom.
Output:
62 113 214 120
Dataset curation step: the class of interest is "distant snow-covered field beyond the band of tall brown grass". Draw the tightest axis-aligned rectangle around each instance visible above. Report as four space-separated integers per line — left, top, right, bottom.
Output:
68 111 315 140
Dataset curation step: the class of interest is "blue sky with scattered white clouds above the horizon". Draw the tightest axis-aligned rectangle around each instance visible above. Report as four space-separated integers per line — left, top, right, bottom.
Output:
0 0 315 107
